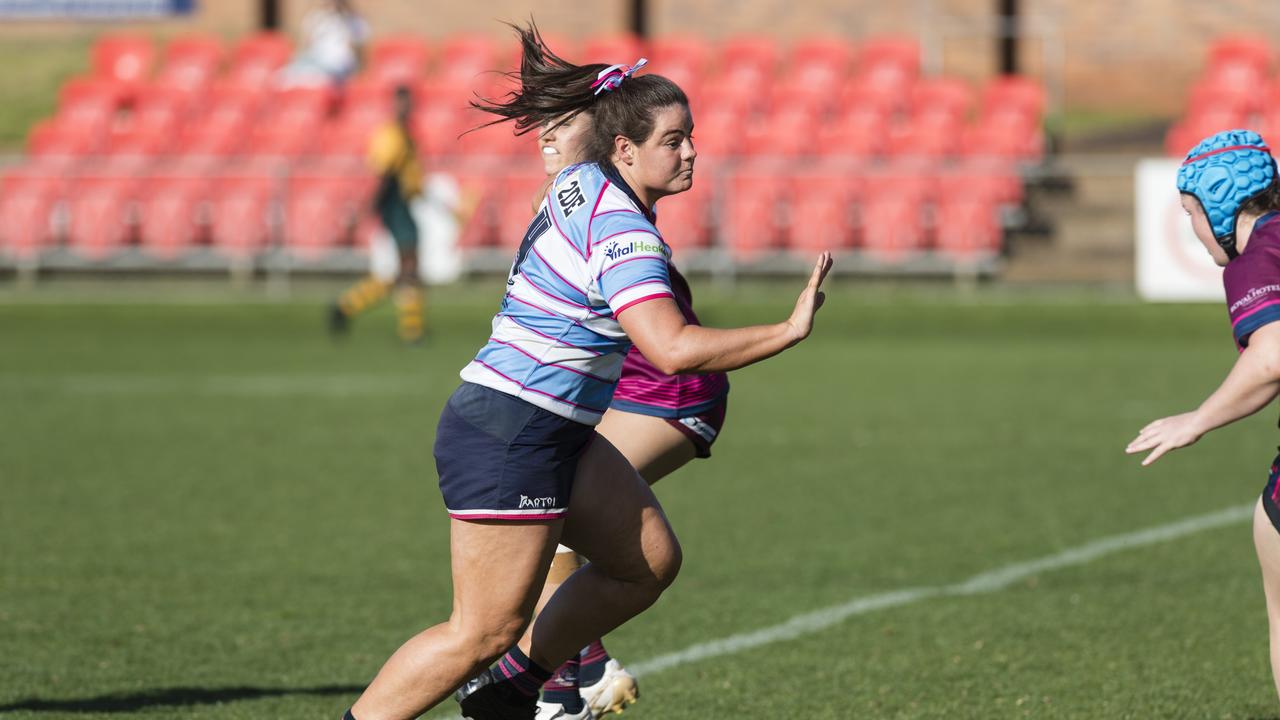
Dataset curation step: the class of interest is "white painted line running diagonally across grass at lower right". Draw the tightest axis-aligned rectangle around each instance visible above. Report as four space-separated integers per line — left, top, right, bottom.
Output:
627 503 1253 675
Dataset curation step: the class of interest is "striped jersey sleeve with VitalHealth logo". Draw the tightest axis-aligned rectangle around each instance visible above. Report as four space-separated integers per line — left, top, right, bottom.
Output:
590 213 676 316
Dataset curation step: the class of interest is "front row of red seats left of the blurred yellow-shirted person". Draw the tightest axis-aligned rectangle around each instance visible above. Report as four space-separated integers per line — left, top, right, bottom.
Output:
0 156 374 261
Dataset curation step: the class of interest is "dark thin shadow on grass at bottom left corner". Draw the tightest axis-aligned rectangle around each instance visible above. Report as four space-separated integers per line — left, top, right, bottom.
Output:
0 685 365 714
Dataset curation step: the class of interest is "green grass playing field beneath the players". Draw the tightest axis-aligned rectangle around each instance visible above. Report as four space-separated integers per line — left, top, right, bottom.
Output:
0 283 1280 720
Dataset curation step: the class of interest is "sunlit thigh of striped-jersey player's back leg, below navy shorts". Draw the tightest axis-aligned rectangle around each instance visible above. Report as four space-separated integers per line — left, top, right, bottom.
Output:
449 519 563 635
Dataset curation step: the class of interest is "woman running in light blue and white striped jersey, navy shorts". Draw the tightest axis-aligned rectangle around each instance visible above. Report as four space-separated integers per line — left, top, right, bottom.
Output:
347 27 831 720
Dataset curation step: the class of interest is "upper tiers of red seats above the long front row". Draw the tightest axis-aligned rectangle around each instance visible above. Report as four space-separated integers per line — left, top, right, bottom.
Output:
47 35 1044 160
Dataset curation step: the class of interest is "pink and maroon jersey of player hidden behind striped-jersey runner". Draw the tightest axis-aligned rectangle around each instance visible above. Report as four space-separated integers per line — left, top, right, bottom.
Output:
609 265 728 418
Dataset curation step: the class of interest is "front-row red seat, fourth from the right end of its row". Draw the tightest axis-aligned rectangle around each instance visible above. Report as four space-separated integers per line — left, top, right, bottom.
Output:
721 163 785 260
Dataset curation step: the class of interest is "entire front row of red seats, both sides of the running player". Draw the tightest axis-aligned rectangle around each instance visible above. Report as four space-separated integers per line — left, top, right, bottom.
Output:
0 155 1023 260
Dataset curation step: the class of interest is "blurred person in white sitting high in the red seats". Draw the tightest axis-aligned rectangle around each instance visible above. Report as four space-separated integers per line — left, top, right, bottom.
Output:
280 0 369 86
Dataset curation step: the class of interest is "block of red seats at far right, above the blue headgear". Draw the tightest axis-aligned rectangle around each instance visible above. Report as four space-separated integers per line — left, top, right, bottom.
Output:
1165 35 1280 156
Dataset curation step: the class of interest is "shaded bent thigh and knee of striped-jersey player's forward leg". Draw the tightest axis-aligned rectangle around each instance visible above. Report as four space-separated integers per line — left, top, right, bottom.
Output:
561 436 680 582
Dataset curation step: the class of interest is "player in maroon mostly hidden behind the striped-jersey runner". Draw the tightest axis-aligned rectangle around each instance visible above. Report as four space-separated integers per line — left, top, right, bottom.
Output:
534 96 728 720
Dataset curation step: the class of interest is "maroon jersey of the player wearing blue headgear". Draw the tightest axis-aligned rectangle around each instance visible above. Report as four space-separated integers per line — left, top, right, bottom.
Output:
1223 213 1280 348
